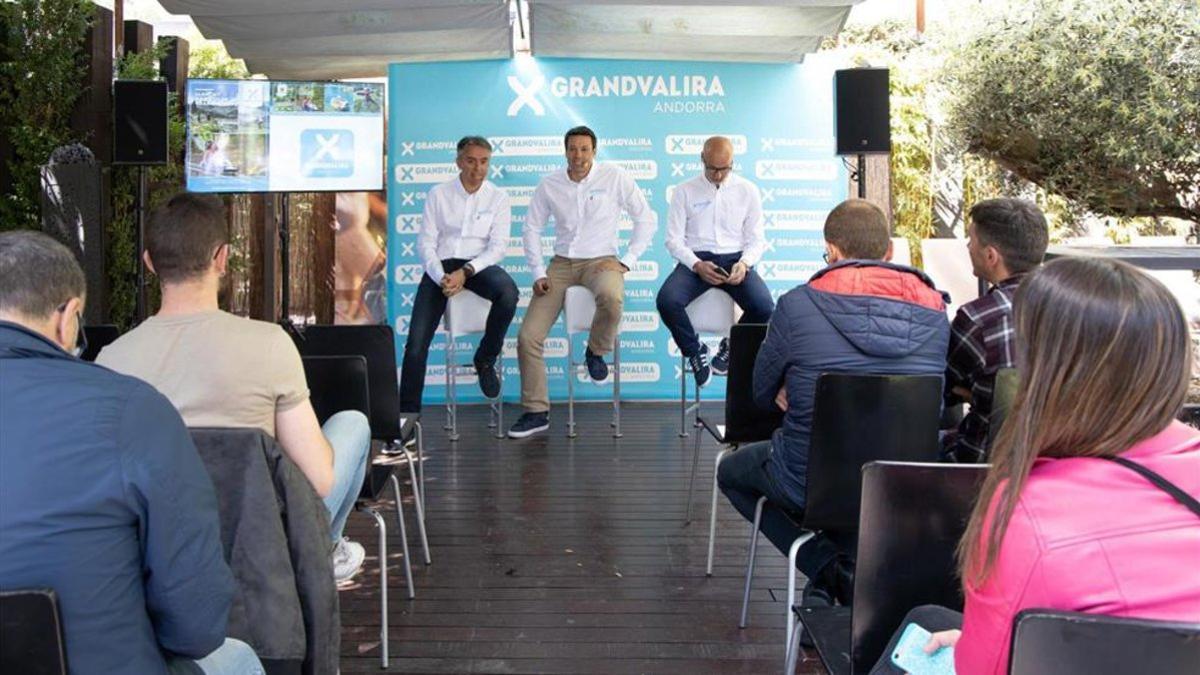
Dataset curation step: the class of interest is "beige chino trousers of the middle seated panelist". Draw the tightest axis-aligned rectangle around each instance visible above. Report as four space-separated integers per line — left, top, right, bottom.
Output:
517 256 625 412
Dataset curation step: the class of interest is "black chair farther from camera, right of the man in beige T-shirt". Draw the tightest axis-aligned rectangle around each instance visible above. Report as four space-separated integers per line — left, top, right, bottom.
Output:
292 324 432 565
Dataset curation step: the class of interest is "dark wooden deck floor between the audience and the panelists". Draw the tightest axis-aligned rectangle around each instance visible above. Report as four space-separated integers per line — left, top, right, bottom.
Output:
341 404 822 674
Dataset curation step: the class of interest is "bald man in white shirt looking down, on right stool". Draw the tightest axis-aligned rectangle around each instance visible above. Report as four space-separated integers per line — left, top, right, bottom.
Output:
658 136 775 387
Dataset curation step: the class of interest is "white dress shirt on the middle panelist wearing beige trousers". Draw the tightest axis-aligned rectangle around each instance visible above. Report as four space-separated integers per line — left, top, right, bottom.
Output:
522 162 658 280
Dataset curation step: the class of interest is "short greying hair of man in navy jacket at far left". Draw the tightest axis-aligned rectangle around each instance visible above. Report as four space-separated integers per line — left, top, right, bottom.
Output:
0 229 88 318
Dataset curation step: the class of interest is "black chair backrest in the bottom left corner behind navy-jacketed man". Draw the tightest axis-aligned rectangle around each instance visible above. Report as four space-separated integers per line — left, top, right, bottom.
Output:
0 589 67 675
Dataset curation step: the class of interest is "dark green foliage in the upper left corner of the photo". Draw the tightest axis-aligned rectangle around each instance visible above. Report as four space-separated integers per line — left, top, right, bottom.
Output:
0 0 92 229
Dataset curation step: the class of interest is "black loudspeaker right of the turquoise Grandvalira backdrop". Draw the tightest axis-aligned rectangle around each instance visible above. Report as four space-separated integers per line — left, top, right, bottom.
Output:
833 68 892 155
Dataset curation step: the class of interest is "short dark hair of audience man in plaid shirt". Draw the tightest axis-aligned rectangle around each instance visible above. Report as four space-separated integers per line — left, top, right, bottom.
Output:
971 197 1050 274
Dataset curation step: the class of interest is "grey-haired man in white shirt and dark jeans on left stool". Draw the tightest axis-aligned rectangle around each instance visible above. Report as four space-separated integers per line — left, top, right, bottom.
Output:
400 136 518 414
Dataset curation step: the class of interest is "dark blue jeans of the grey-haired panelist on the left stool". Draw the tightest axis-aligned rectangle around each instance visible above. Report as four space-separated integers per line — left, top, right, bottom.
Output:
400 258 520 412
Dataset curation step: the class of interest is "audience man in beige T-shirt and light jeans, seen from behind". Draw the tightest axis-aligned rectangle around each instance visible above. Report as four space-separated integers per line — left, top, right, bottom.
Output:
96 193 371 581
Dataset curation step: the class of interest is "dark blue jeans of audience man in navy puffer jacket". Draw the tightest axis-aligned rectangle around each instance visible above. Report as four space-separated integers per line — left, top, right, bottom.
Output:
716 441 853 579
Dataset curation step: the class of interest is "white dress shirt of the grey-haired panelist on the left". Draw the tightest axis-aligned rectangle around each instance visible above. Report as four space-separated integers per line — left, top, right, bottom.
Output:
416 178 512 283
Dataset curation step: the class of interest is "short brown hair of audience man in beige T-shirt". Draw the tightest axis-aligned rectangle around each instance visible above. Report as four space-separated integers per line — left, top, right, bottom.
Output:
146 192 229 283
